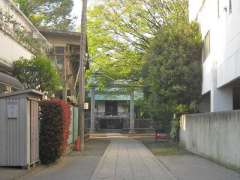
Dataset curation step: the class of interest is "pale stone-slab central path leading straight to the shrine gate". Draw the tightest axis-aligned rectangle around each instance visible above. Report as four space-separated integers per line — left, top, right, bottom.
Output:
91 139 176 180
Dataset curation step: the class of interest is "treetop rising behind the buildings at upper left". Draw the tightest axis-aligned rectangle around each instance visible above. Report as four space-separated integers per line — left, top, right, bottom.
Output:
15 0 73 30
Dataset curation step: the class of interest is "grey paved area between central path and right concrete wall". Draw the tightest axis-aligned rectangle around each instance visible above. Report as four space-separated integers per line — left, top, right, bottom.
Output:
158 154 240 180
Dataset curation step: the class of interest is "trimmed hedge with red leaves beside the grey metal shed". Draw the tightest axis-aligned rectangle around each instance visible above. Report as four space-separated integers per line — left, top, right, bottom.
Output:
39 99 70 164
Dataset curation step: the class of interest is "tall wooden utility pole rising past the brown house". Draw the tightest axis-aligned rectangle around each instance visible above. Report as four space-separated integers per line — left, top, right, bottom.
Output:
78 0 87 151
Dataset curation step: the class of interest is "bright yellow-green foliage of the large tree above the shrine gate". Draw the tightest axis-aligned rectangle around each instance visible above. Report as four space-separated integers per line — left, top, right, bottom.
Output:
88 0 186 88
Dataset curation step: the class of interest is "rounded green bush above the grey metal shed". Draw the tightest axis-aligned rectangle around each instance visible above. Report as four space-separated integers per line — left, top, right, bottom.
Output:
13 55 61 94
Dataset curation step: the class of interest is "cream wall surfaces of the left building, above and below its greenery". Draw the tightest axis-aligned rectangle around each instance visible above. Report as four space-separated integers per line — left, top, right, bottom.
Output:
0 0 47 67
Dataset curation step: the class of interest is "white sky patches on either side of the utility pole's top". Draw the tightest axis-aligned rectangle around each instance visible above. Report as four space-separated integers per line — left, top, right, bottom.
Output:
72 0 101 26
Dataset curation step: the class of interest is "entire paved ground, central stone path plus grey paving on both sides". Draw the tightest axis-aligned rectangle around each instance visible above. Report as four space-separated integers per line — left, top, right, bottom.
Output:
0 138 240 180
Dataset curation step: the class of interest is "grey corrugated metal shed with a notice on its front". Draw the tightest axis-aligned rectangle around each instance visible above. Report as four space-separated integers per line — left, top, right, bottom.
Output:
0 90 43 167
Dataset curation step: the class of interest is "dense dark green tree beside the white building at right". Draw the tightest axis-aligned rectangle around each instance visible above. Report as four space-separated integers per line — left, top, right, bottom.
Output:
143 20 201 130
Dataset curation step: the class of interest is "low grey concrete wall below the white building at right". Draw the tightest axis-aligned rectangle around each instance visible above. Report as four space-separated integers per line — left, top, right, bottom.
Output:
180 111 240 169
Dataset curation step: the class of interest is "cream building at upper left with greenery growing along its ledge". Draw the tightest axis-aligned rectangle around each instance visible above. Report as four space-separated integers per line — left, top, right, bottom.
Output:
0 0 48 93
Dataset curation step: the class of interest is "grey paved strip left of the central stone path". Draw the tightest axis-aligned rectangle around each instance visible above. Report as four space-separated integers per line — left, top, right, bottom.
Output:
17 140 109 180
